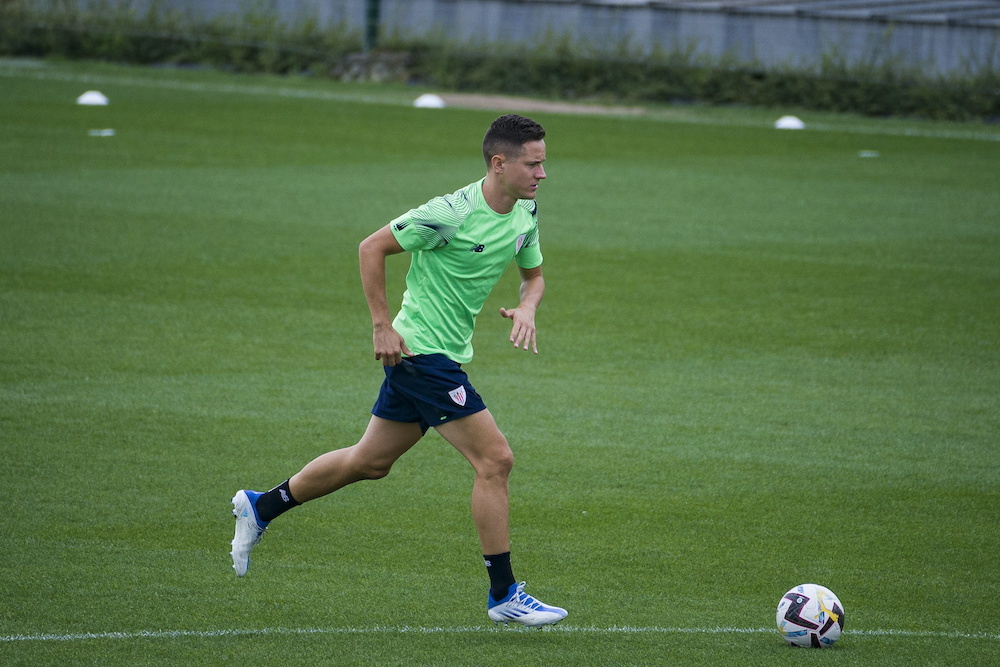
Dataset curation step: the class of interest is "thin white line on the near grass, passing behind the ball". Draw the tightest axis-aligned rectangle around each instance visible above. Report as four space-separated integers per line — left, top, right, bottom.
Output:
0 625 1000 643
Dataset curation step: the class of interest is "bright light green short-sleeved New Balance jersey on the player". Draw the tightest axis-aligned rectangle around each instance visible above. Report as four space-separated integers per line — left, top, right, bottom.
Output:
389 179 542 364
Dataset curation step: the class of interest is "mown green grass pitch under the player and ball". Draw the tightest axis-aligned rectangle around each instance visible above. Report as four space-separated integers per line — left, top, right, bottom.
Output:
0 61 1000 665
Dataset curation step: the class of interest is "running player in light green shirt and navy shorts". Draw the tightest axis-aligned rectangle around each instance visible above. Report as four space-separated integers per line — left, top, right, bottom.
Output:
231 115 566 626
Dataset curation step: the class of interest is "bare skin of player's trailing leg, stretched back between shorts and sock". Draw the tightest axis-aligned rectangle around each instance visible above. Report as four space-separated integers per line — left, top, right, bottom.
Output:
288 416 423 503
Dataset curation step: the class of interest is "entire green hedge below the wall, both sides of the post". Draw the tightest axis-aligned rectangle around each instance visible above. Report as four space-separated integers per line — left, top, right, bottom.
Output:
0 0 1000 121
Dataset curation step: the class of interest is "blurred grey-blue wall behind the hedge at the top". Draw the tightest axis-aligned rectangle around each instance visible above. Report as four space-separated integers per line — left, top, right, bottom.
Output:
146 0 1000 73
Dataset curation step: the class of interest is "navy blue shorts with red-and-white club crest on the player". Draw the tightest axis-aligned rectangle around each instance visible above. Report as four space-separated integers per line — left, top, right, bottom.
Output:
372 354 486 433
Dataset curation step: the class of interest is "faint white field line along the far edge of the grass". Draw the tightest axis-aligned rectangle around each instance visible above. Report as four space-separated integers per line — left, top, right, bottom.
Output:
0 60 1000 141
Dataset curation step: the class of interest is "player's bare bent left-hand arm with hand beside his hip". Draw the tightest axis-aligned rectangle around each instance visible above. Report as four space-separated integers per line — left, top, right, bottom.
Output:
358 225 412 366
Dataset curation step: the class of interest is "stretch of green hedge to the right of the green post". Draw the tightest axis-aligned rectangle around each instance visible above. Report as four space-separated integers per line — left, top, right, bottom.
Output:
414 33 1000 120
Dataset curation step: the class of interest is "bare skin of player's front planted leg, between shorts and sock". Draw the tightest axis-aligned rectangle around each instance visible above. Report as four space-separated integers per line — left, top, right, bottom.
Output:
436 410 514 554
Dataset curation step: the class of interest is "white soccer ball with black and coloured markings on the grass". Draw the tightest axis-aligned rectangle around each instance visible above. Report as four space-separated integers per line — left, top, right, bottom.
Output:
775 584 844 648
